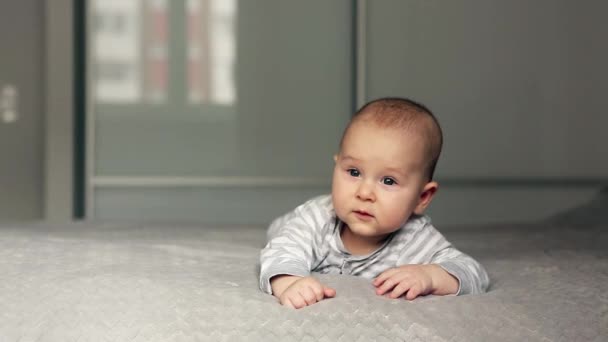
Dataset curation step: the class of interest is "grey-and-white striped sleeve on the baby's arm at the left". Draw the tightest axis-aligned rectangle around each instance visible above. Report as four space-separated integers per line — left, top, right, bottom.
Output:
260 196 328 294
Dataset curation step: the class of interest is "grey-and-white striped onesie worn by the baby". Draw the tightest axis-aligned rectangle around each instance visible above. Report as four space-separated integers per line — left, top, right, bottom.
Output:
260 195 489 295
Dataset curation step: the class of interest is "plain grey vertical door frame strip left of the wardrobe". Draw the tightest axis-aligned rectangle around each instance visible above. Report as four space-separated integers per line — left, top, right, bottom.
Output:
43 0 75 221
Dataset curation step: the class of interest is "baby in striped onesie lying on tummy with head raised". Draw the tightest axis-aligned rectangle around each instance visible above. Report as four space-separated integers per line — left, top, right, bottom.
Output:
260 98 489 309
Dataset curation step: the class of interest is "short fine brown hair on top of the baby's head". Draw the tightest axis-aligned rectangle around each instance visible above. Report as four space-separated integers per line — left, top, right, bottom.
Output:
340 97 443 181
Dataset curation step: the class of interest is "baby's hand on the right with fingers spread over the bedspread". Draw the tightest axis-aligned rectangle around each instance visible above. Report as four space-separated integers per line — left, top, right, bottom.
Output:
372 264 458 300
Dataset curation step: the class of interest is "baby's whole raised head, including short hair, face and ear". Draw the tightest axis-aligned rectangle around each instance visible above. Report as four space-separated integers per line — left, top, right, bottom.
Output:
332 98 443 242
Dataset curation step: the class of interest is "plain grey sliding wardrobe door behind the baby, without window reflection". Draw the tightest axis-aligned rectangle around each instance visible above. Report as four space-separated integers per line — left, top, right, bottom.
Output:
363 0 608 223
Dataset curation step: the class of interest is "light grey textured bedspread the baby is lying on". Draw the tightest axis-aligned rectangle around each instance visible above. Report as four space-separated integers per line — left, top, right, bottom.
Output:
0 223 608 342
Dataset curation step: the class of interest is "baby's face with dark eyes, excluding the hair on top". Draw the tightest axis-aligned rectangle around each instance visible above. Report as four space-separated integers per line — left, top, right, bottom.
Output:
332 120 427 238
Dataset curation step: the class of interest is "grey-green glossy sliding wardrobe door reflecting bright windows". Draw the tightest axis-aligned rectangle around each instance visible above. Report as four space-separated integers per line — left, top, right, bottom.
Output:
87 0 353 224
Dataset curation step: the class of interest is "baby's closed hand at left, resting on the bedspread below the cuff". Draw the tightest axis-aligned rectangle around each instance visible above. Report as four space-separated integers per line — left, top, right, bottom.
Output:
270 275 336 309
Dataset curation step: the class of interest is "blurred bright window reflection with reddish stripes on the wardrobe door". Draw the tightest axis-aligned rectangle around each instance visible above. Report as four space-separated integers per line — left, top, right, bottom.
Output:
90 0 237 105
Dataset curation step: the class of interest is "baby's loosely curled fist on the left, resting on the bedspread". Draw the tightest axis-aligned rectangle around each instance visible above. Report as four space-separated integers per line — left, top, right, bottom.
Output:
278 277 336 309
